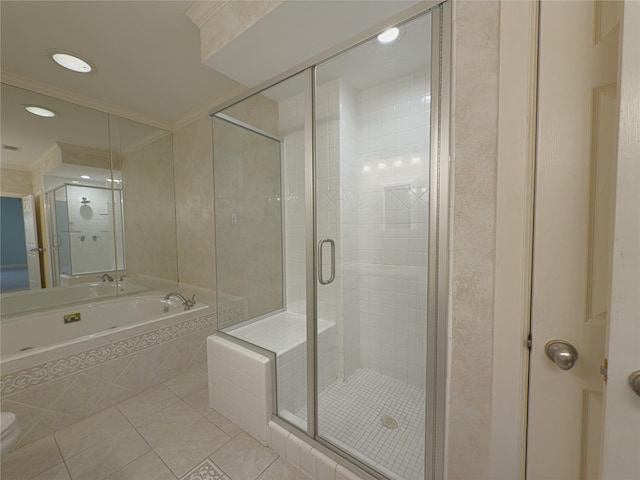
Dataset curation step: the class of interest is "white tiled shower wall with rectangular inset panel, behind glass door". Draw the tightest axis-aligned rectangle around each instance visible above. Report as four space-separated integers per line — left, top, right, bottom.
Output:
357 71 430 387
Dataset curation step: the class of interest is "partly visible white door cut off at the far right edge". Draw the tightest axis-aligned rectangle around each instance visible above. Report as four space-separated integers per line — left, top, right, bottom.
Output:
602 1 640 480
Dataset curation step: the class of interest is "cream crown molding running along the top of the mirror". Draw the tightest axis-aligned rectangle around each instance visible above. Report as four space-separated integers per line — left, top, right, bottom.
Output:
0 72 173 131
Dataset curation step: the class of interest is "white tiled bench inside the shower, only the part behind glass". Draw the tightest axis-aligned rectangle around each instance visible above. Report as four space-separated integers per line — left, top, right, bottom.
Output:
226 312 337 429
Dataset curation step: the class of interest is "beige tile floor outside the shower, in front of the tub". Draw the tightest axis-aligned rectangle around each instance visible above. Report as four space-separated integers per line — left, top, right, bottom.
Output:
0 369 308 480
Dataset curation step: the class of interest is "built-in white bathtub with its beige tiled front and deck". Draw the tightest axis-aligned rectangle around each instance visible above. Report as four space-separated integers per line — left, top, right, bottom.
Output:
0 289 246 447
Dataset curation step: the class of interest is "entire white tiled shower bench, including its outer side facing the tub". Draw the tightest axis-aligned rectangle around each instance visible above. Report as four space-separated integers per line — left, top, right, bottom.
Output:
207 312 338 445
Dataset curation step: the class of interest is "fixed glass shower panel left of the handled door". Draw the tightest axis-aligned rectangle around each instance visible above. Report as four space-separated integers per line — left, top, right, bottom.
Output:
213 72 312 431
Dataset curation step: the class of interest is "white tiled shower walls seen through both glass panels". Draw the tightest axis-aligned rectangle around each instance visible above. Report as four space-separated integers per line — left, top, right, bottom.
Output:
278 71 430 387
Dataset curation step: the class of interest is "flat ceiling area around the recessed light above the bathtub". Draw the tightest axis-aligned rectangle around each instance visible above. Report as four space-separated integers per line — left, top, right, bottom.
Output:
0 0 242 125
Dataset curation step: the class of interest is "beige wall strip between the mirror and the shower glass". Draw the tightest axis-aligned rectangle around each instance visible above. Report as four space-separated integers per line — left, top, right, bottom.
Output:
173 115 216 290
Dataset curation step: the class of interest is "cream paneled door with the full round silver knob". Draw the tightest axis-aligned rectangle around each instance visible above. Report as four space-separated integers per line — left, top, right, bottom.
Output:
527 1 621 480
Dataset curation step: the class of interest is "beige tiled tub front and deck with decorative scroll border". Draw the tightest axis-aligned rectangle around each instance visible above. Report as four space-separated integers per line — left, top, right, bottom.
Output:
0 296 242 448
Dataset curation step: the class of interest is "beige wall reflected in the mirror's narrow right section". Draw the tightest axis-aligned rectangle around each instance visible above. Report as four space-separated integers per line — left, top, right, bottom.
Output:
122 134 178 281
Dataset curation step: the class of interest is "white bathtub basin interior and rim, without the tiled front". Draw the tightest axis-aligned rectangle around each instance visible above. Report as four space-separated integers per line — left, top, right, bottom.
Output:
1 292 208 361
